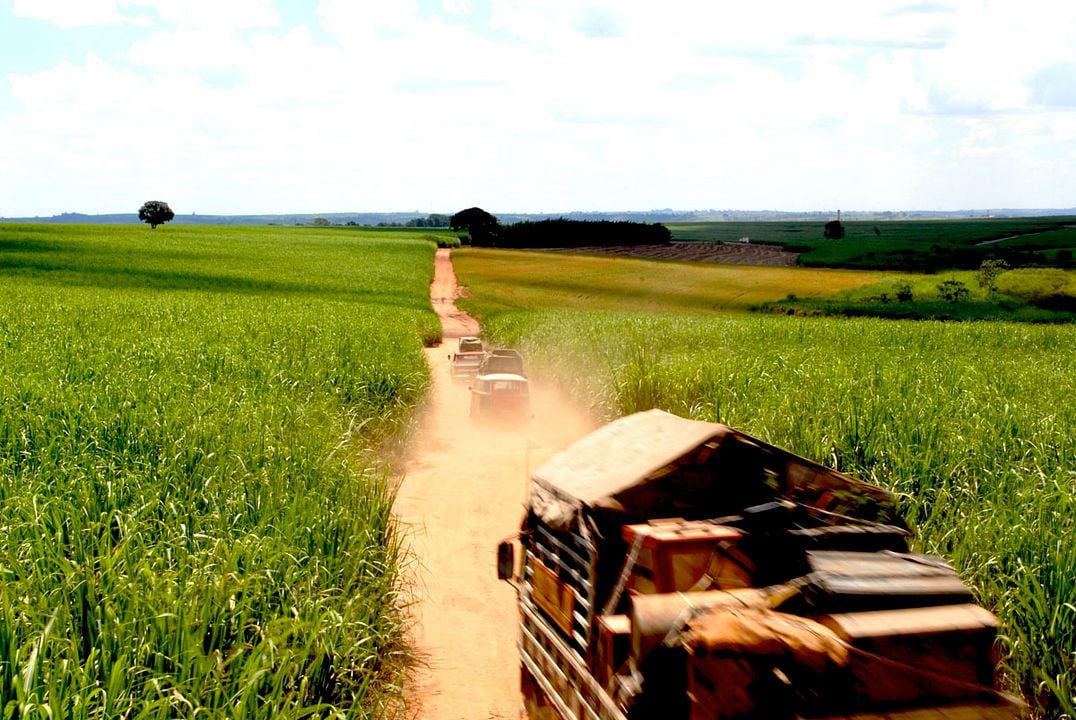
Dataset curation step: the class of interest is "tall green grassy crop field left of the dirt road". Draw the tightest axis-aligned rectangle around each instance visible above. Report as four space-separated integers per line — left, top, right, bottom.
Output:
0 224 440 718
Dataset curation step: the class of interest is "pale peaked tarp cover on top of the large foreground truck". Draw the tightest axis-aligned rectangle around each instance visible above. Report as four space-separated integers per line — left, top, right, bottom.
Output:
530 410 893 527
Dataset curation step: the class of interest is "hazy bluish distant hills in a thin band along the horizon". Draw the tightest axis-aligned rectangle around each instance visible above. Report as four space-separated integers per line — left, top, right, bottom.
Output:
0 208 1076 226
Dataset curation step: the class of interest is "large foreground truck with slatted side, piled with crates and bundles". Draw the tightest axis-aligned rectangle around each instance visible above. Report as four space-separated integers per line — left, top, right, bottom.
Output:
497 410 1025 720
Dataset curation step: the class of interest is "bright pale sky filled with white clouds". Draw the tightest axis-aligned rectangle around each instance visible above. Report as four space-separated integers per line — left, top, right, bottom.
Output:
0 0 1076 217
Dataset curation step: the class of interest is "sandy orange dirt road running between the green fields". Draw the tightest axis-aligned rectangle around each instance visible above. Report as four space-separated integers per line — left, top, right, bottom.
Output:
396 250 593 720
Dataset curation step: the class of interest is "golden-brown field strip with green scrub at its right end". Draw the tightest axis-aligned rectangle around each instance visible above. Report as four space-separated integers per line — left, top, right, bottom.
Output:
453 248 1076 323
